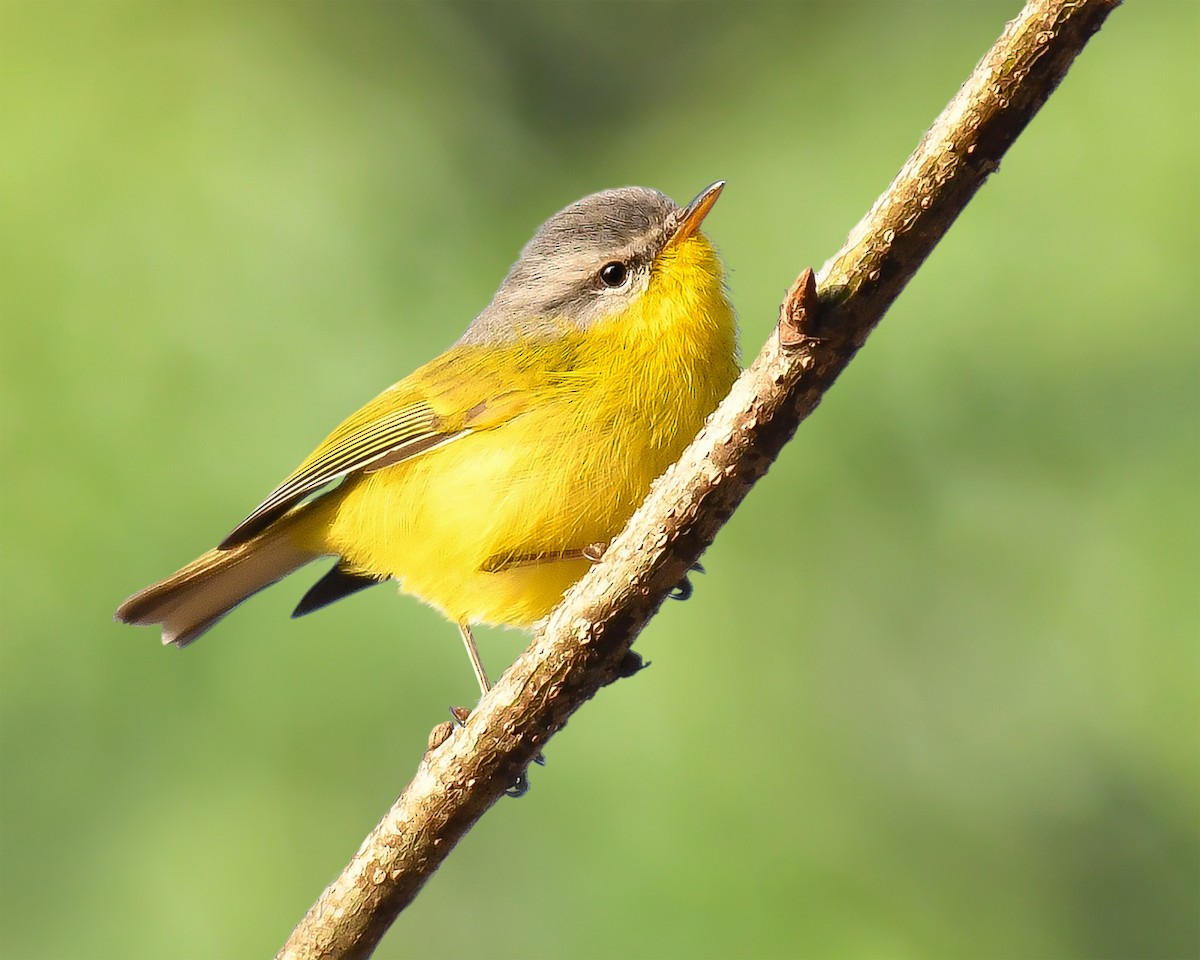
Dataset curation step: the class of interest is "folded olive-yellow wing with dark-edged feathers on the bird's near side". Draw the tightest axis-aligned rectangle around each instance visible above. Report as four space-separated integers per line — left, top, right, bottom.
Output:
221 352 544 550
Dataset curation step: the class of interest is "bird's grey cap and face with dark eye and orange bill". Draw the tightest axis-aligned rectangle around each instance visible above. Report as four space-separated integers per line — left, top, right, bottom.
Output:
458 181 725 344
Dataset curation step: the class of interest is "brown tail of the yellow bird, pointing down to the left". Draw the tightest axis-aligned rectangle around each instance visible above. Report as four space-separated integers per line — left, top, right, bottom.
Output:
116 508 320 647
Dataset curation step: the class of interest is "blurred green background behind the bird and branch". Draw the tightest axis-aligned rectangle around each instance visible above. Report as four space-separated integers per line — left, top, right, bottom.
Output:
0 0 1200 958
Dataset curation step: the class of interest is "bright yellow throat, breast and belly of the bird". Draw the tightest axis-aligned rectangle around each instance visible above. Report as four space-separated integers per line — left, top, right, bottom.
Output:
309 235 738 626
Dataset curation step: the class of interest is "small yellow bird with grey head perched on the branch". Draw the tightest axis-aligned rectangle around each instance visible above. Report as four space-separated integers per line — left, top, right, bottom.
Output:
115 180 739 692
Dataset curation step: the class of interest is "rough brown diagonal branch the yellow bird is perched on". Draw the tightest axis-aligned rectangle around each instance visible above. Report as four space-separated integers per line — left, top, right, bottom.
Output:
278 0 1118 960
